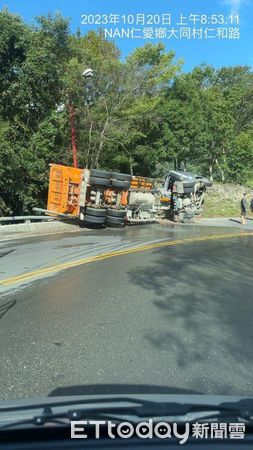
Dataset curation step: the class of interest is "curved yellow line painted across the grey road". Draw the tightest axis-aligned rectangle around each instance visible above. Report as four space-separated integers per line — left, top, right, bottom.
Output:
0 232 253 286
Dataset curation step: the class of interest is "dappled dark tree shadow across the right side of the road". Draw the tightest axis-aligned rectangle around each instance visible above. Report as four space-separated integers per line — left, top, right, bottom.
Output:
128 238 253 394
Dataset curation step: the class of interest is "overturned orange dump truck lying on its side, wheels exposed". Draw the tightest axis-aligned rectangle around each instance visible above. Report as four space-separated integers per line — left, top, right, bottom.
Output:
45 164 212 227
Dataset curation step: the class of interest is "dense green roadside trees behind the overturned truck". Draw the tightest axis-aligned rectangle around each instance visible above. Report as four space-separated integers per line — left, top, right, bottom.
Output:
0 9 253 214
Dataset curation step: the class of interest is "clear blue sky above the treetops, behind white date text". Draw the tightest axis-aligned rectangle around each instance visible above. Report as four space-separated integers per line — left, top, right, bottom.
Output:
0 0 253 71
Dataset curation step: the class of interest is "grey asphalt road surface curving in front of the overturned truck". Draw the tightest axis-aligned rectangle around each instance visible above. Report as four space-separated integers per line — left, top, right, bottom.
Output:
0 225 253 399
